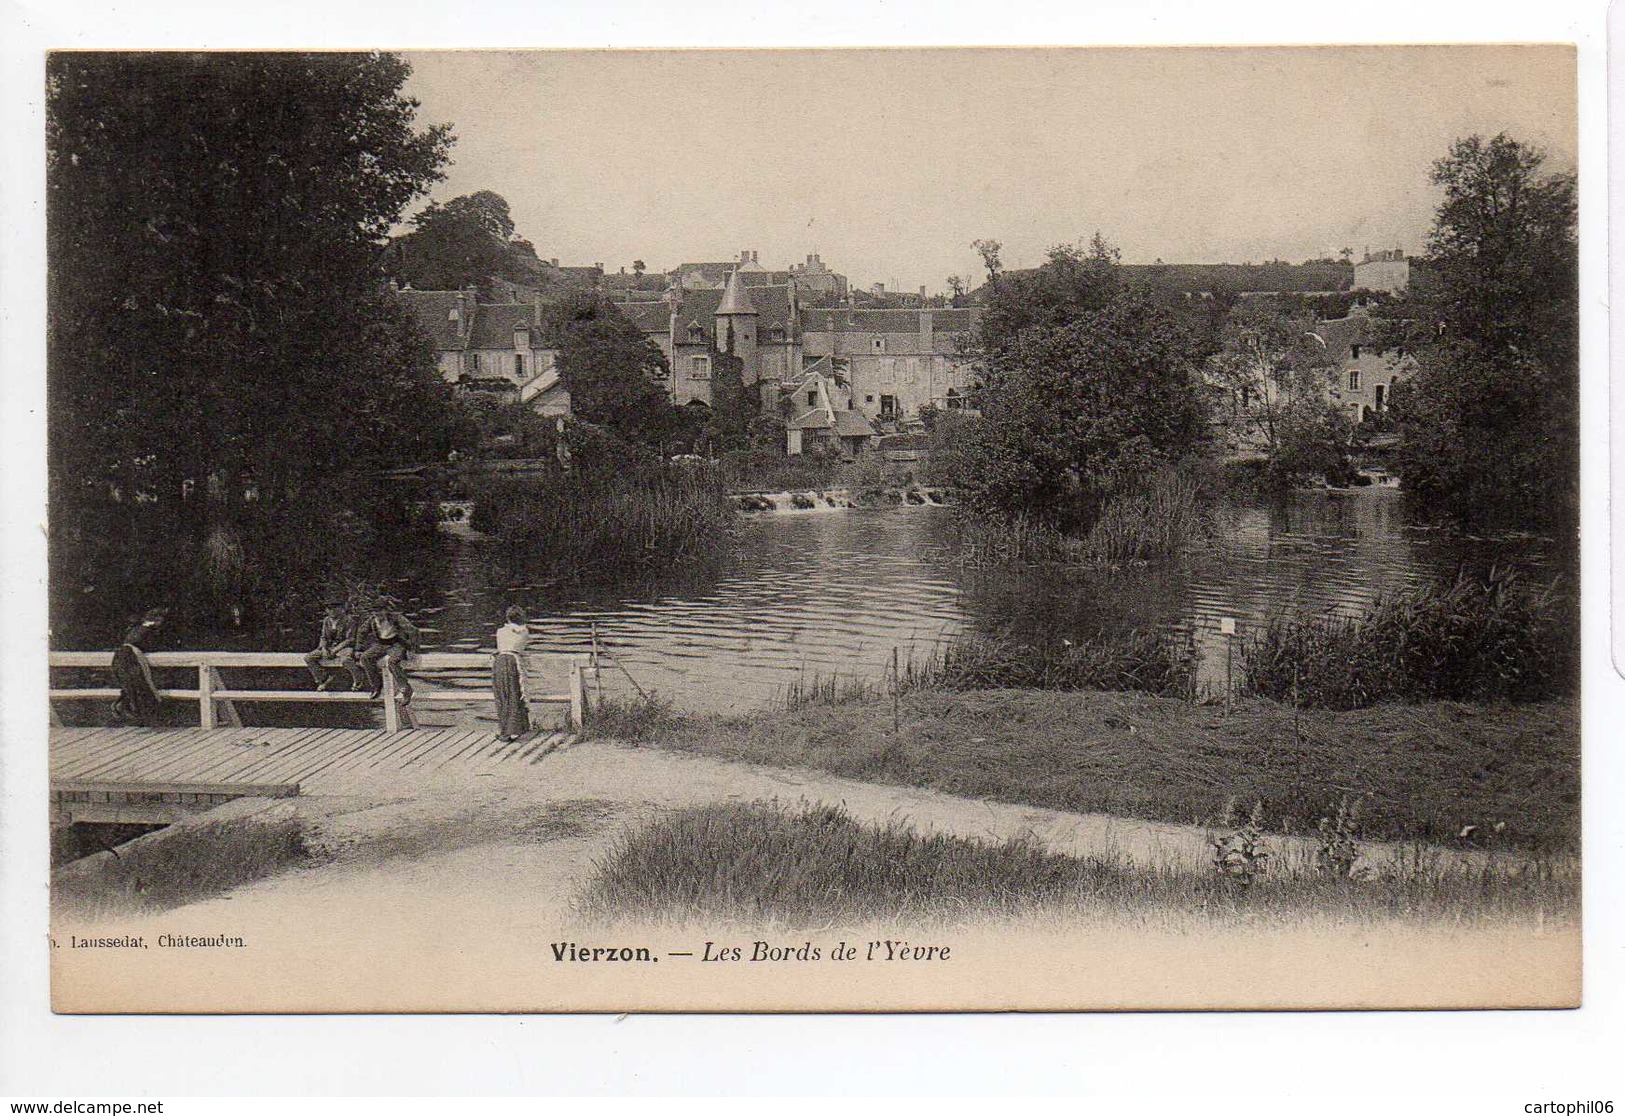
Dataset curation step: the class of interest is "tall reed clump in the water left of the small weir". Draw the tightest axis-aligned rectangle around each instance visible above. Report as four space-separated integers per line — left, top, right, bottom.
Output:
473 469 735 580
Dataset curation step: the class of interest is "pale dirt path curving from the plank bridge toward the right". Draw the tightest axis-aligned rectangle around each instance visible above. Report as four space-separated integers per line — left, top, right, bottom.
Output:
60 741 1508 932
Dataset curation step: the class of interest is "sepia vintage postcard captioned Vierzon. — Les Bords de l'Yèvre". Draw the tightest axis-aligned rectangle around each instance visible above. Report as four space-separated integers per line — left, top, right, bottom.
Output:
39 44 1581 1014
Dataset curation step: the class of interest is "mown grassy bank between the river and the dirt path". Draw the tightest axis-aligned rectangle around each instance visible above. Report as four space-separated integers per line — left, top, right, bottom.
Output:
592 690 1580 853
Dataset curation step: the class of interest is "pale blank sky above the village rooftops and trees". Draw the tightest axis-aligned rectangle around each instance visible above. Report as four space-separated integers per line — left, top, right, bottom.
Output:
396 45 1576 292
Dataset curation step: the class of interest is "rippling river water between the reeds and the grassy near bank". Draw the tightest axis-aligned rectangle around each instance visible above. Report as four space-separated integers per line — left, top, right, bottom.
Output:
386 489 1550 712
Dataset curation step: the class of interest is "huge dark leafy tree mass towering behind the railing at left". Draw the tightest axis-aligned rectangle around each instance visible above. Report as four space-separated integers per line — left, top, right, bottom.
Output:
47 54 450 636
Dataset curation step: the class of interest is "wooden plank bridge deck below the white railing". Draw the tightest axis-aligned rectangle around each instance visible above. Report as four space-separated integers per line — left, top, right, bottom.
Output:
50 726 575 822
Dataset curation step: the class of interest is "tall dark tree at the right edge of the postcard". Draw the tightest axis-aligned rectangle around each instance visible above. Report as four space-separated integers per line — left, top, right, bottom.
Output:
1393 135 1580 533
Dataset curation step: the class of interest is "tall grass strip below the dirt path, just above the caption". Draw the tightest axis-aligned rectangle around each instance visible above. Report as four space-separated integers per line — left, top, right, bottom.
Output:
580 802 1578 928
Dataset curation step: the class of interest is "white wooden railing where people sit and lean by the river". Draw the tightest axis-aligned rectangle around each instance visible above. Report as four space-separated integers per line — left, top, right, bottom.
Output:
50 651 595 733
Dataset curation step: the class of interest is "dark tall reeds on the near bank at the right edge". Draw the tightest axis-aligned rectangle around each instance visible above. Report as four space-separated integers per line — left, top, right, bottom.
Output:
1242 570 1578 710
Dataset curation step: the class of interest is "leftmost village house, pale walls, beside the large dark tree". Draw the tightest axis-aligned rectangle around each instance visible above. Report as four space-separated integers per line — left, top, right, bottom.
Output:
395 286 570 416
